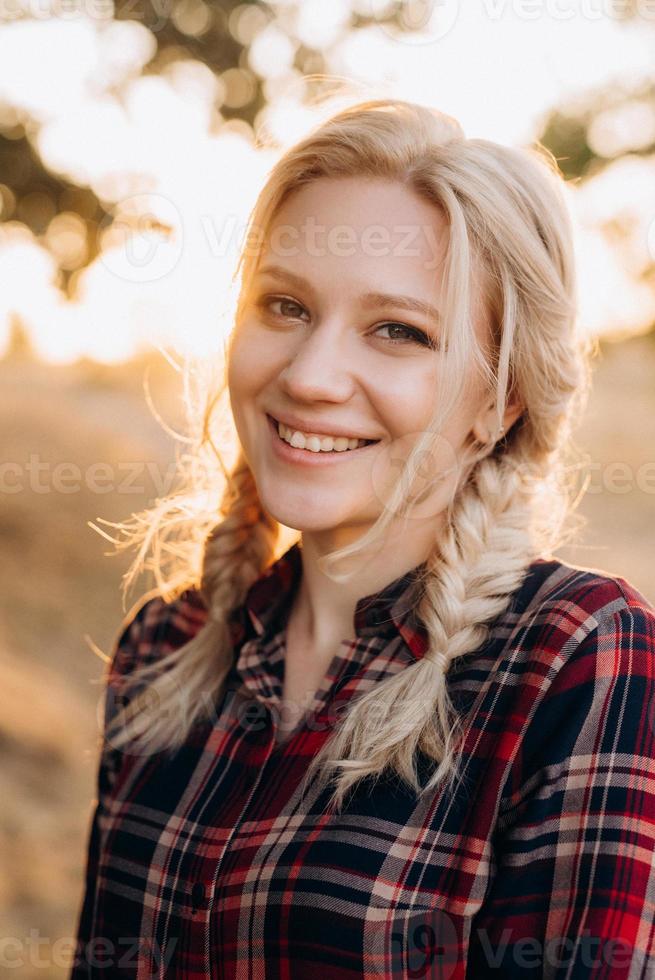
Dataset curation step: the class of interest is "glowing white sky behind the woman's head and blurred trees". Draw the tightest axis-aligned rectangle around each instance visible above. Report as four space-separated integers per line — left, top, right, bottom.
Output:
0 0 655 361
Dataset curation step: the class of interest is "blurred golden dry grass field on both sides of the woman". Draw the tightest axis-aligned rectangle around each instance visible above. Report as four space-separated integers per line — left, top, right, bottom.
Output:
0 334 655 980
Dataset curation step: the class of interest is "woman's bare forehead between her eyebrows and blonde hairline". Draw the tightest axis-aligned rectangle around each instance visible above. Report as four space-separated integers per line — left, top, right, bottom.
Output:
258 177 489 341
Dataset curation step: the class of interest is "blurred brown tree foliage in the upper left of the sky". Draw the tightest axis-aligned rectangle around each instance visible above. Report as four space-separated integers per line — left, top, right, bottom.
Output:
0 0 410 292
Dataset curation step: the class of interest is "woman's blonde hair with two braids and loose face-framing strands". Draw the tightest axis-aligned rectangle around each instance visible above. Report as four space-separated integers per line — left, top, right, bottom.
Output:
101 98 591 809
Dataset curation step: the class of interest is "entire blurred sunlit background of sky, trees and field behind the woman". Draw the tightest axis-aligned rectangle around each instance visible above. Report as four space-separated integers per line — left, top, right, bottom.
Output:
0 0 655 978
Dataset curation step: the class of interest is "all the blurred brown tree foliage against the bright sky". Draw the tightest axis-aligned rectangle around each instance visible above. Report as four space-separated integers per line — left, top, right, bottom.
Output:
0 0 655 310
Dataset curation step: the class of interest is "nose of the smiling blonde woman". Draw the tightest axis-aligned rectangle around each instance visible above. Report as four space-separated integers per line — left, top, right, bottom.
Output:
279 319 356 401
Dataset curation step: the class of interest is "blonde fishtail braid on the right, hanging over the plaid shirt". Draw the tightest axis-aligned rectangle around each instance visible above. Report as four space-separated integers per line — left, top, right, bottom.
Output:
305 456 534 808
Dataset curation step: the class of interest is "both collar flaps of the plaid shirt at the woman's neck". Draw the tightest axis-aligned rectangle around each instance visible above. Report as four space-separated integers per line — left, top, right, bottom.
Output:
228 541 428 660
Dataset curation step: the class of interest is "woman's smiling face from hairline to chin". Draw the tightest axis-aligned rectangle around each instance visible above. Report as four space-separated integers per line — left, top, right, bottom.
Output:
228 177 500 550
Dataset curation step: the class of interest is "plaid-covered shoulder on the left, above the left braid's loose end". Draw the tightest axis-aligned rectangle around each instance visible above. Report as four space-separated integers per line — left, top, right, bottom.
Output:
107 588 207 682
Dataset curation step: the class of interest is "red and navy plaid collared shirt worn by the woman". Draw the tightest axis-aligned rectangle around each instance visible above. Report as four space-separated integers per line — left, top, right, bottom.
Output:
71 545 655 980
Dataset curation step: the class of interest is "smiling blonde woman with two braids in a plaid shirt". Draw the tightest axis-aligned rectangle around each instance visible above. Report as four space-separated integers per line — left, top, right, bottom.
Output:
72 100 655 980
